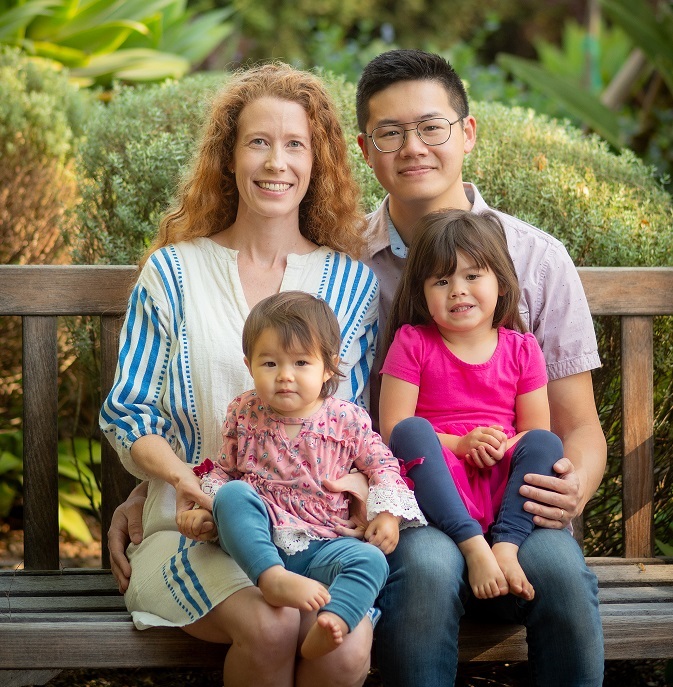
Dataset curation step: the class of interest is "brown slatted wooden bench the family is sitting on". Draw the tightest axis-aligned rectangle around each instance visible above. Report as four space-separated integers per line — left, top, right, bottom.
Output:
0 266 673 685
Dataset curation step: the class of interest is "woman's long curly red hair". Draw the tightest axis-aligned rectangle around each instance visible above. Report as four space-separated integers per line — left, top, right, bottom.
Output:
144 63 365 264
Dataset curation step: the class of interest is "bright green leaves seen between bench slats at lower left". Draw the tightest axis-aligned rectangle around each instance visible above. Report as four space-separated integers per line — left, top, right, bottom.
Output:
0 432 101 543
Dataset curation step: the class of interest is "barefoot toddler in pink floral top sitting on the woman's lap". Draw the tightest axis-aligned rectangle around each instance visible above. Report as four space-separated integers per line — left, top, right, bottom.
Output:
178 291 426 659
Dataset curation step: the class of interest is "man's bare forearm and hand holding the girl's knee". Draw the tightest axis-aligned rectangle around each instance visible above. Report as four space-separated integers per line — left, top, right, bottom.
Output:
520 372 607 529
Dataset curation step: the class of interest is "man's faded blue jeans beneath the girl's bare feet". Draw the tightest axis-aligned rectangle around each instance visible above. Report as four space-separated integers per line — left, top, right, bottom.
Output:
375 416 604 687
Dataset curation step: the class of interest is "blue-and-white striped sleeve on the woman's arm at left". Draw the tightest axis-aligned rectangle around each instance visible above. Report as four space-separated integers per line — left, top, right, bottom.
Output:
99 260 177 479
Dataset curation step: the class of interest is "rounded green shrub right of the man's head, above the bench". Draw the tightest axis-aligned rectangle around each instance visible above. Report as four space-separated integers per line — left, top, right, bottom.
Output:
463 103 673 266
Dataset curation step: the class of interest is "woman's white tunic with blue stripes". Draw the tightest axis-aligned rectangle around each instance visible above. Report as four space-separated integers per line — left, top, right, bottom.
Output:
100 238 378 629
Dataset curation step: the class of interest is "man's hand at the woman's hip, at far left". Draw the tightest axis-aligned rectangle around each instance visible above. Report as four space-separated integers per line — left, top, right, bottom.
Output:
107 482 147 594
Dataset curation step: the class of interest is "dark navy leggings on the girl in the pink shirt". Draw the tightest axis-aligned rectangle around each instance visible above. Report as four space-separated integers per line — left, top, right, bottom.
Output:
390 417 563 547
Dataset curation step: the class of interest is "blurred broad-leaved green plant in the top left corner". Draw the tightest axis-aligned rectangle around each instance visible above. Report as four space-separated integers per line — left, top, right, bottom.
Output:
0 0 233 86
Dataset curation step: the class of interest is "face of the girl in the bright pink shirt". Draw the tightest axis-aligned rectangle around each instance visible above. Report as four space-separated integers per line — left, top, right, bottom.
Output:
423 251 500 334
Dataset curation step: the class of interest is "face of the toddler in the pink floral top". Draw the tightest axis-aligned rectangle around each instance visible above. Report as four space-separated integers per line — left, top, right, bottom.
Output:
245 328 332 417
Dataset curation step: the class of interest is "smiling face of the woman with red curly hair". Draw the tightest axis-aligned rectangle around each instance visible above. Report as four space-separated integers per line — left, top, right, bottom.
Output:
232 97 313 227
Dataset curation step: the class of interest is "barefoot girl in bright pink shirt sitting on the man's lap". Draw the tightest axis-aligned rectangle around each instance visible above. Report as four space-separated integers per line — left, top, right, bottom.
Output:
380 210 563 599
